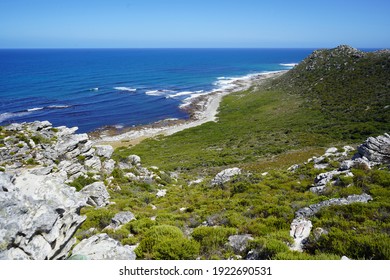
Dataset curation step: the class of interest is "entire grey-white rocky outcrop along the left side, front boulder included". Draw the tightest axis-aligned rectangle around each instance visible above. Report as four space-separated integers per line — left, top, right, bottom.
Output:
0 121 121 259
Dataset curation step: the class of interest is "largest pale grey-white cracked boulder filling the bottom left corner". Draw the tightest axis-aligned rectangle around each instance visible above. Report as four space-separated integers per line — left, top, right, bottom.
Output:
0 170 86 259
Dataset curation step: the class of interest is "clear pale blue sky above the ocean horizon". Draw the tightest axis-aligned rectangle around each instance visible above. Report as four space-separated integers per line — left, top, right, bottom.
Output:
0 0 390 48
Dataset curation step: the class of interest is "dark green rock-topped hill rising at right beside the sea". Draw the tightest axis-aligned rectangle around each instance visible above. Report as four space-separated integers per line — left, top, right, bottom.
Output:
275 45 390 137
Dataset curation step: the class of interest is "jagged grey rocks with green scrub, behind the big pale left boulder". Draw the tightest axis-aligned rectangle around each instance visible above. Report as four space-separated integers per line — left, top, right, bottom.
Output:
0 121 113 181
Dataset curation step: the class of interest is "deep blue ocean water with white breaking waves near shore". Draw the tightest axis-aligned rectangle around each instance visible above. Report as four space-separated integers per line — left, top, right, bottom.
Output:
0 49 313 132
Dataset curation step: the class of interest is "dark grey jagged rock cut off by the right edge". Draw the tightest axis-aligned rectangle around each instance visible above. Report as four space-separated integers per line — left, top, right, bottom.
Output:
358 133 390 164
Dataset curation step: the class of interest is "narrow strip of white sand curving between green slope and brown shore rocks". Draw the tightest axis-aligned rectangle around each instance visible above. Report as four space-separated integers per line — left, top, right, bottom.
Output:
93 71 286 146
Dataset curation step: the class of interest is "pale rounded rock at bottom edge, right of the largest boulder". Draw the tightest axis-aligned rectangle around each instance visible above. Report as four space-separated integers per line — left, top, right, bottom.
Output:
70 233 136 260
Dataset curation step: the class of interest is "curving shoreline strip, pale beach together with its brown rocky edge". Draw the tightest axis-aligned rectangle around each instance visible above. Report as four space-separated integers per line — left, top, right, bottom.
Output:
89 70 288 148
